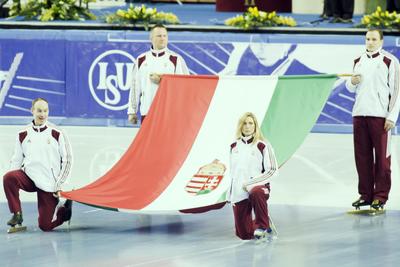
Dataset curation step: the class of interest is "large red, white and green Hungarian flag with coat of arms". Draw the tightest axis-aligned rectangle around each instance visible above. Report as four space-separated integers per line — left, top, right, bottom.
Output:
62 75 337 213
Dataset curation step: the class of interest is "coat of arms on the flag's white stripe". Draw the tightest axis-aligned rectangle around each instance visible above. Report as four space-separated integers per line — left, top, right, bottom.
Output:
185 159 226 196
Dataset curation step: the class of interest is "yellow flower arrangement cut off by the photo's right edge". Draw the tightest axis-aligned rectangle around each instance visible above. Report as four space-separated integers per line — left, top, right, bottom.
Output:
357 6 400 29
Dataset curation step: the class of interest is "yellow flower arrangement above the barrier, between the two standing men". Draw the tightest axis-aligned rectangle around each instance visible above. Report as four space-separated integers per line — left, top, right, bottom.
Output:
225 7 297 30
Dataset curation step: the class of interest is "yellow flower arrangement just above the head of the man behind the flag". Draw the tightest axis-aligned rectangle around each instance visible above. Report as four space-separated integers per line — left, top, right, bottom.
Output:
106 4 180 29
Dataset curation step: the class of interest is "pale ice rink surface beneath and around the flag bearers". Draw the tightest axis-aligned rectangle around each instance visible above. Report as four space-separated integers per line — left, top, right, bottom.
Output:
0 126 400 267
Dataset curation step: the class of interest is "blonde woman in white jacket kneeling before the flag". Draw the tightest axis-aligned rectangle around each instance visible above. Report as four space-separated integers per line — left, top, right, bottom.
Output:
228 112 278 242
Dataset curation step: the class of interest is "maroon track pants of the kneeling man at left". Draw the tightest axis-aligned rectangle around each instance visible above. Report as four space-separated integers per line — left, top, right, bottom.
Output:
3 170 66 231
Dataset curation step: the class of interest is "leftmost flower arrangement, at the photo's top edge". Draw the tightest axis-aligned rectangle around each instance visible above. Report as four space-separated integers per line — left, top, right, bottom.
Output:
9 0 96 21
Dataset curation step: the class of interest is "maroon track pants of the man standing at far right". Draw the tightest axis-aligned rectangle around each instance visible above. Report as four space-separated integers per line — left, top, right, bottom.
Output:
353 116 391 203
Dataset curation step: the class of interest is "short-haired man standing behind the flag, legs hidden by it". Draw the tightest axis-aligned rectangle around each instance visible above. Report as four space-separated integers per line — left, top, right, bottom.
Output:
128 24 189 123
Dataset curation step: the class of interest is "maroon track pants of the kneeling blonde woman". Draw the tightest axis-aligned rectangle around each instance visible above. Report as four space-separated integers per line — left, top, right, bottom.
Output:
233 185 270 239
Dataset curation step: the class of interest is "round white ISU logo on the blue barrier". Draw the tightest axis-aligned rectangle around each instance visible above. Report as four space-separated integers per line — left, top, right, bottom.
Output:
88 50 135 110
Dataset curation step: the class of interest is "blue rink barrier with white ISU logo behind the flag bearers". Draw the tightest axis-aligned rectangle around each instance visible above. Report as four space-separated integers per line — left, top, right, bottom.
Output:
0 30 400 132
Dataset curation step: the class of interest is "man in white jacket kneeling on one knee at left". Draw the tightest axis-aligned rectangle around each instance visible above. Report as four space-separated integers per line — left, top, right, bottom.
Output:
3 98 72 231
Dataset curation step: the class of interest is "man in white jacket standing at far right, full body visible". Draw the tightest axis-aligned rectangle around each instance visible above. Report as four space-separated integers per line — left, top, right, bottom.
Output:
346 29 400 209
